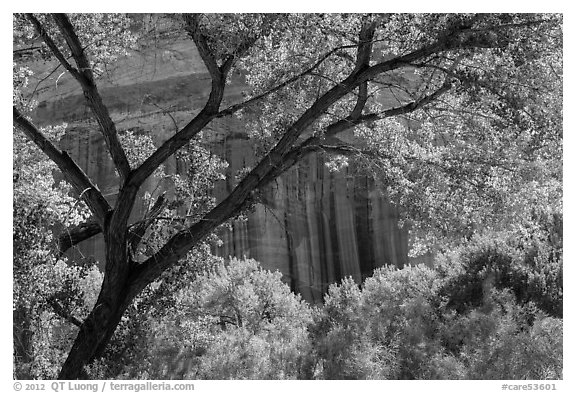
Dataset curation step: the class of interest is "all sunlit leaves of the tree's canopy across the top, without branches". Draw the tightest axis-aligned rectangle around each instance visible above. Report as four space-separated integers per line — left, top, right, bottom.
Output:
14 14 562 262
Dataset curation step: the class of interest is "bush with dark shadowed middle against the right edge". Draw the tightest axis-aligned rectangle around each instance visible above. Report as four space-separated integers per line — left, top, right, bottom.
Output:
436 231 563 318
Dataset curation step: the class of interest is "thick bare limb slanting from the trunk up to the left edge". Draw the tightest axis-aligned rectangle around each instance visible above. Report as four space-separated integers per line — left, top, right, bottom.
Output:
13 107 112 225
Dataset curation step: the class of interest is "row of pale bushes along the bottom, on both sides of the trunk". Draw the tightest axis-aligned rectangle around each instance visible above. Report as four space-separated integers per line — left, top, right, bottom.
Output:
16 225 562 380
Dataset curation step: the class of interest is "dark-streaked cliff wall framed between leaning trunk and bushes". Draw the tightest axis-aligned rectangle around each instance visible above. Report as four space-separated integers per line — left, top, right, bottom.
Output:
209 134 408 301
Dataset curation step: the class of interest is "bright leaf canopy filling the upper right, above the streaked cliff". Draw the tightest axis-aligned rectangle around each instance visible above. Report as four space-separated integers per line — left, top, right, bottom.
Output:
234 14 562 255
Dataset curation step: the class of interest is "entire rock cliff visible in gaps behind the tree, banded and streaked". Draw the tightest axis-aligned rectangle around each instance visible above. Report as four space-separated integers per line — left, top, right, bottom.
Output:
24 35 408 302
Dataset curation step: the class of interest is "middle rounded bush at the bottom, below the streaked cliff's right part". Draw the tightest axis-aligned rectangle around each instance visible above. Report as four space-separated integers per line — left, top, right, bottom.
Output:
312 266 437 379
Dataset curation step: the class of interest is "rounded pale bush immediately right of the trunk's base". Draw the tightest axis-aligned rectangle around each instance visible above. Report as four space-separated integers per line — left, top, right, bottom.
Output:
92 260 311 379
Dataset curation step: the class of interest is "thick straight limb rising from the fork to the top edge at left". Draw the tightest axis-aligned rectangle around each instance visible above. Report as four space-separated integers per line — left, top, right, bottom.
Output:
53 14 130 182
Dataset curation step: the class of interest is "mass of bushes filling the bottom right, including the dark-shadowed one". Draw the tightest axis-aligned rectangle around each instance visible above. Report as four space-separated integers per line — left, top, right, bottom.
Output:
312 231 562 379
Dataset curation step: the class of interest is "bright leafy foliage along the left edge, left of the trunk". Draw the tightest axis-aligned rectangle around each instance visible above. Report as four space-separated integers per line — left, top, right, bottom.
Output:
12 127 102 379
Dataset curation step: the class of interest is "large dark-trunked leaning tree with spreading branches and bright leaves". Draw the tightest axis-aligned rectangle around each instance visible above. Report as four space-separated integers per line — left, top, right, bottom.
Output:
13 14 562 379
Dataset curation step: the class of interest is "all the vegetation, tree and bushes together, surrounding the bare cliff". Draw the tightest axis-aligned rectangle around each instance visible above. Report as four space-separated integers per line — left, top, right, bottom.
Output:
13 14 562 379
